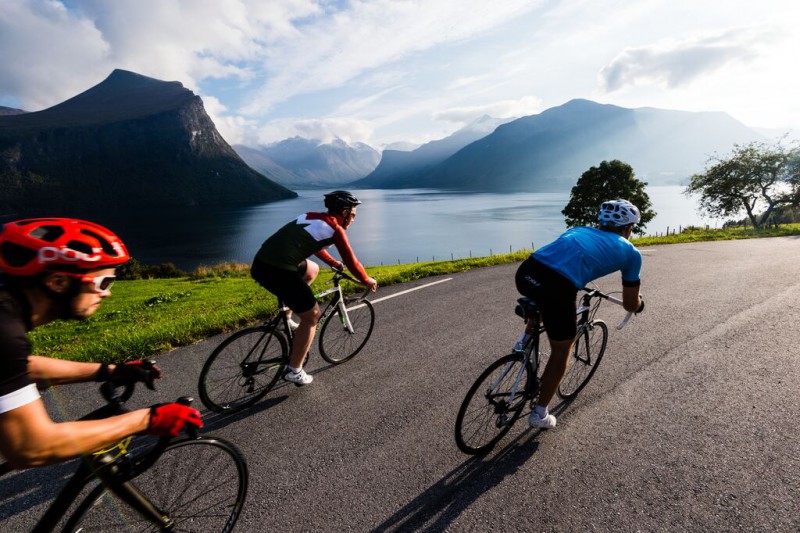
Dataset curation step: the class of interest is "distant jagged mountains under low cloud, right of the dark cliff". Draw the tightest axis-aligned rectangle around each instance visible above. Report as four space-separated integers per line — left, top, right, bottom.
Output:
234 137 380 188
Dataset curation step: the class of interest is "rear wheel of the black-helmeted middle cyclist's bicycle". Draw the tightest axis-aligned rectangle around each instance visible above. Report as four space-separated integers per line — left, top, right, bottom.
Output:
198 326 289 413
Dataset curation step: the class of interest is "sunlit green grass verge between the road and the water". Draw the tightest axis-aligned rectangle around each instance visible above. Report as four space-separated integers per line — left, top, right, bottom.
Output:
31 224 800 362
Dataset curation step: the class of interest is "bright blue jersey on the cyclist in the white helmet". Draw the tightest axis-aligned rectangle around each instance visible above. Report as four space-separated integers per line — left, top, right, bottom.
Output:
531 227 642 289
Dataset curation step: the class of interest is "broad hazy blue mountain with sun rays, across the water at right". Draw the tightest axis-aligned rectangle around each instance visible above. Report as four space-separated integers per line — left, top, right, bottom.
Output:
360 100 763 192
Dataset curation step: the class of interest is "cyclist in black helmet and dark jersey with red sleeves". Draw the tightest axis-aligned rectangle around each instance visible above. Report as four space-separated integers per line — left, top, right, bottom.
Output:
250 191 378 386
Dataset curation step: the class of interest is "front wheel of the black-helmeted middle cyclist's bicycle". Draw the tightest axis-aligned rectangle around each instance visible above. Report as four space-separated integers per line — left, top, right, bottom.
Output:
319 298 375 365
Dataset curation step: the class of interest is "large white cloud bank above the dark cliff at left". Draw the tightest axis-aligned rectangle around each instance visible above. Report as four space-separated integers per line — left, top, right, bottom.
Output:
0 0 322 110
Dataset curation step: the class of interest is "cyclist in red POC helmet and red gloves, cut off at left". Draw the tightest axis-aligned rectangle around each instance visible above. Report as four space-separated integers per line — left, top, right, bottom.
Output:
0 218 202 468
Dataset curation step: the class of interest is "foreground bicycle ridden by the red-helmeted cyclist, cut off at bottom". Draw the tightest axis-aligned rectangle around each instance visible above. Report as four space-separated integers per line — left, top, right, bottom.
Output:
0 368 248 533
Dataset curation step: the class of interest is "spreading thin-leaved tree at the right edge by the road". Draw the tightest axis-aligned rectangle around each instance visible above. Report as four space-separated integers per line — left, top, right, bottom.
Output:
685 141 800 229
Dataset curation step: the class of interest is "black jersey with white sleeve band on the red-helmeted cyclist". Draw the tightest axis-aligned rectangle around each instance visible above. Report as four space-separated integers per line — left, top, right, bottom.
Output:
0 286 39 413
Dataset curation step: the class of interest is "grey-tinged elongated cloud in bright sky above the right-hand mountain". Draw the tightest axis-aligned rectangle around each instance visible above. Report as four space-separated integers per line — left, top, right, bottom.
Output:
599 28 765 92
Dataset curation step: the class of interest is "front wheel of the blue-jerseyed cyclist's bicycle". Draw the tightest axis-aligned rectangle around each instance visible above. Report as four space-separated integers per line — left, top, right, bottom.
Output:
558 320 608 400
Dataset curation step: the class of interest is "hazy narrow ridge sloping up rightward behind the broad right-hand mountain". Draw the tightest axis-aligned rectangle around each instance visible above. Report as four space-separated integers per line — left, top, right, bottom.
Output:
353 115 508 189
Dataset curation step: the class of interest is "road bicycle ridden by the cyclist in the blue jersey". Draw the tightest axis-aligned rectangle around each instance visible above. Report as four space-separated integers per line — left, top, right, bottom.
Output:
455 288 633 454
